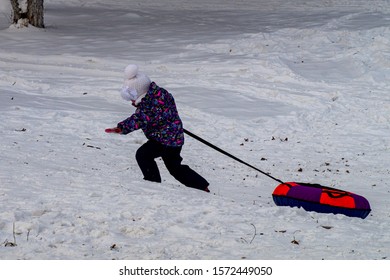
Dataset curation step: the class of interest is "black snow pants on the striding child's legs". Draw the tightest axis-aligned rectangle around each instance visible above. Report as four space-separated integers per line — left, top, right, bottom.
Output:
135 140 209 190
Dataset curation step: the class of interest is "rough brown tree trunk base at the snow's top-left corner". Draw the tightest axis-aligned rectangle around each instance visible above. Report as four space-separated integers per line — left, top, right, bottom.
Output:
11 0 45 28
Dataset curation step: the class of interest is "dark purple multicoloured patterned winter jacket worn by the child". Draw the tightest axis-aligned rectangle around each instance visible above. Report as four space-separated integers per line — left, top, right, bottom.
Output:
117 82 184 147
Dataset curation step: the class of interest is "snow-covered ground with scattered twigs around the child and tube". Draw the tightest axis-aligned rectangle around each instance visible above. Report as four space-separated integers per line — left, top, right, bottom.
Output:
0 0 390 260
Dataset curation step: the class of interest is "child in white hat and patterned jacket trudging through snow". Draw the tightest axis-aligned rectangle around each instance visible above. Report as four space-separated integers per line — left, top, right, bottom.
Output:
106 64 210 192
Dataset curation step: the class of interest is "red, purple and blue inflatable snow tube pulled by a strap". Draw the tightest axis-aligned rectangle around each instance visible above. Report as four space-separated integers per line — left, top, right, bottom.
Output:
272 182 371 219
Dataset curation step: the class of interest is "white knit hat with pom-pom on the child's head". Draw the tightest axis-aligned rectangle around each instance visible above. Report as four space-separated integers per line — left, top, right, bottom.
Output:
121 64 151 101
